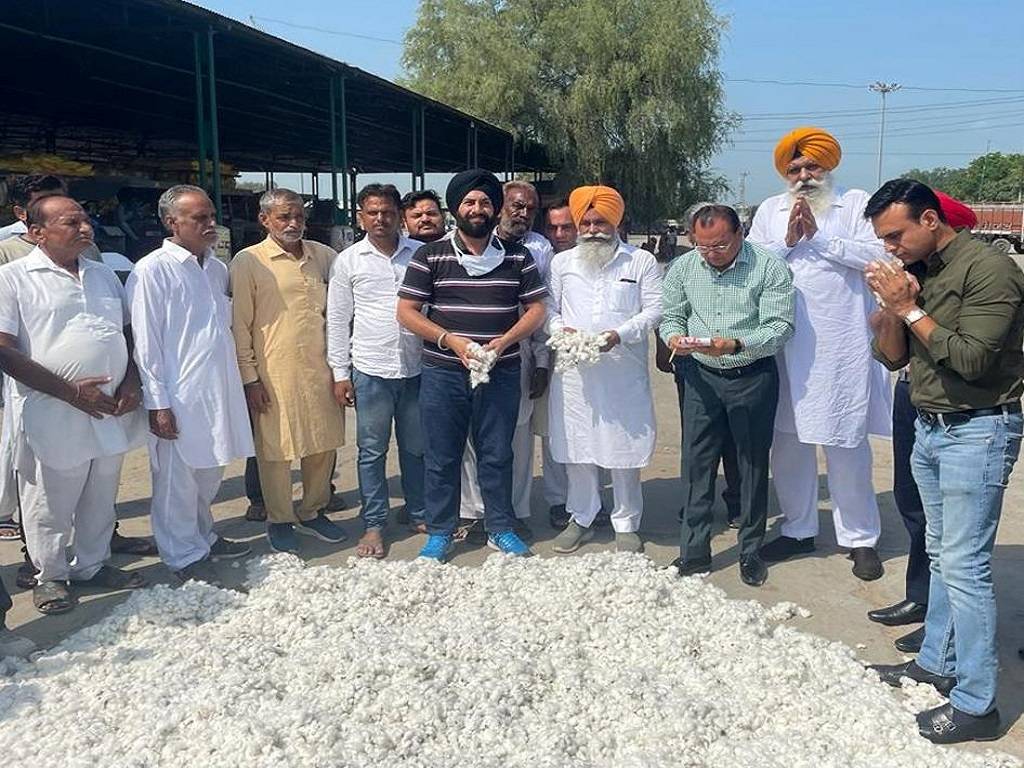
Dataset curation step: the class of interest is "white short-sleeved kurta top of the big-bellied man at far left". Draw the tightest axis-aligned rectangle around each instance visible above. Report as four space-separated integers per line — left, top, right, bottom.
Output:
0 248 145 471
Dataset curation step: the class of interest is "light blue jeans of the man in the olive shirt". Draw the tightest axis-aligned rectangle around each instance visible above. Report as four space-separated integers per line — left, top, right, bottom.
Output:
910 414 1024 716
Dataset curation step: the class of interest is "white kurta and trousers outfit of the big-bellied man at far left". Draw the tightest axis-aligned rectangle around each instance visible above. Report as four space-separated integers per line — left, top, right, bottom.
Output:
0 248 144 582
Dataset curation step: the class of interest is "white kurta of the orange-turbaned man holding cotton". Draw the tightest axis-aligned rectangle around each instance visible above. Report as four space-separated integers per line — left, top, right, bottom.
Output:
547 244 662 469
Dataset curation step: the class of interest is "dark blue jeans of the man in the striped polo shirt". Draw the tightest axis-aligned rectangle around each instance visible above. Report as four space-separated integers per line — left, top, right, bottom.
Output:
420 361 519 535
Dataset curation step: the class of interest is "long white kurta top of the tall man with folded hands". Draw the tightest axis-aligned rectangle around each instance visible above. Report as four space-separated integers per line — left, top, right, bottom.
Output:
750 189 892 449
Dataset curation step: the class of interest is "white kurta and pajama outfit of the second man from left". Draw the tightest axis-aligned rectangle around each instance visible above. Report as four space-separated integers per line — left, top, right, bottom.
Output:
128 240 253 570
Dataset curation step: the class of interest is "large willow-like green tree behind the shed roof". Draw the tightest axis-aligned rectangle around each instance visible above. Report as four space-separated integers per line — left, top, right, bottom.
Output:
402 0 735 223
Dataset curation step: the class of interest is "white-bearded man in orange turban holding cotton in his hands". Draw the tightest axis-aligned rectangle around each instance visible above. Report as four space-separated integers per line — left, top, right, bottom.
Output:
548 186 662 553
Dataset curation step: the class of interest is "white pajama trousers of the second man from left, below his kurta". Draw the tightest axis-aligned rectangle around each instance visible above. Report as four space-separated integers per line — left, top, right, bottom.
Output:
150 437 224 570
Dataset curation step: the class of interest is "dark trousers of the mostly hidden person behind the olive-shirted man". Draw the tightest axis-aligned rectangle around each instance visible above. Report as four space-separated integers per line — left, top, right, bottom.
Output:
893 381 932 605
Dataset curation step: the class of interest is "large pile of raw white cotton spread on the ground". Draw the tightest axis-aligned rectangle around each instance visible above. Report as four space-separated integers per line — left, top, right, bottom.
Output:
0 553 1018 768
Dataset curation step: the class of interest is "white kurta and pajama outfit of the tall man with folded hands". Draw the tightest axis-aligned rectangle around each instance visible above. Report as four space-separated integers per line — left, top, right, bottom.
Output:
750 189 892 548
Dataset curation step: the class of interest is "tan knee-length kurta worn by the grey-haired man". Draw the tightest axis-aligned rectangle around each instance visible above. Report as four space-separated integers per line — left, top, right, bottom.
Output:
231 238 345 461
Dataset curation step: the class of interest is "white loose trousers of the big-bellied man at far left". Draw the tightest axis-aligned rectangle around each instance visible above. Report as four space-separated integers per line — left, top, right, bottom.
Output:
17 455 124 582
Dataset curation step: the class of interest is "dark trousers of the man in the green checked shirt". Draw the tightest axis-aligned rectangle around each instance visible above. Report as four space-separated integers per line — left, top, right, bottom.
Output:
679 357 778 560
